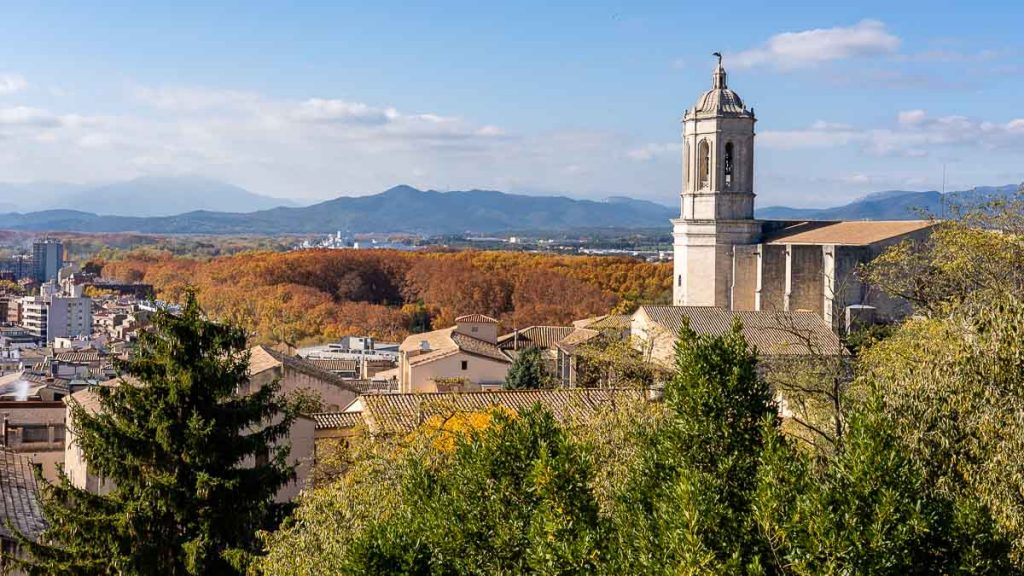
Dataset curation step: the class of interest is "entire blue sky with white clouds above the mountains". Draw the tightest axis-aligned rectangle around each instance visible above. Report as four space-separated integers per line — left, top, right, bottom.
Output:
0 0 1024 207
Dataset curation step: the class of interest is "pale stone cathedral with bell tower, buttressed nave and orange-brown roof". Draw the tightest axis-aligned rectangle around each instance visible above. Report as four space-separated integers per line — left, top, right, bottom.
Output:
672 54 933 331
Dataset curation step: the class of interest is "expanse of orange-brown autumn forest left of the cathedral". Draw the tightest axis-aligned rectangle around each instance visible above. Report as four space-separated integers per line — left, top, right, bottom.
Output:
97 250 672 345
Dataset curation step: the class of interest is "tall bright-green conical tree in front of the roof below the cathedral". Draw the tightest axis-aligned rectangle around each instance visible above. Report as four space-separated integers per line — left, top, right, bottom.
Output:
613 317 786 574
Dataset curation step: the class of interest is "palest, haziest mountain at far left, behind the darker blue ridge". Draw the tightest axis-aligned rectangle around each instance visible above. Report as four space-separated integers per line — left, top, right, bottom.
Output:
0 176 295 216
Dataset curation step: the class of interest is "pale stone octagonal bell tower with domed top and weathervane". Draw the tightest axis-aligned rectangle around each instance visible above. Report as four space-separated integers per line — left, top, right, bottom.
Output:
672 52 761 307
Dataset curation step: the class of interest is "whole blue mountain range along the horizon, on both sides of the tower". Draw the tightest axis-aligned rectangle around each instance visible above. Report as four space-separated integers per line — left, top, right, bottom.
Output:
0 178 1018 236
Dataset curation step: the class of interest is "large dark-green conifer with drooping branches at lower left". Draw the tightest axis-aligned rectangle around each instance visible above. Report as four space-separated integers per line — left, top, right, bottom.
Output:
14 293 295 575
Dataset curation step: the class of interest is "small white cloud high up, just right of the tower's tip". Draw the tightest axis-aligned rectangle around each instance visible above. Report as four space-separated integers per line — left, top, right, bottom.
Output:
728 19 900 69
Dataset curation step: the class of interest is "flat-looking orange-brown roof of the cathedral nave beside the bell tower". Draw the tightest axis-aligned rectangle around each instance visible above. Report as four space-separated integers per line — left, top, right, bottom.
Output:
764 220 936 246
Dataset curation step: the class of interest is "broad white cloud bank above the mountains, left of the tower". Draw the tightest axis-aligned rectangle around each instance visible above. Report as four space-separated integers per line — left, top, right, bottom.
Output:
0 86 678 200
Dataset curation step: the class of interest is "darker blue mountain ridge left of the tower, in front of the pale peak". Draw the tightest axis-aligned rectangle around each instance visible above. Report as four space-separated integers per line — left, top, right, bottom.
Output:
0 186 676 235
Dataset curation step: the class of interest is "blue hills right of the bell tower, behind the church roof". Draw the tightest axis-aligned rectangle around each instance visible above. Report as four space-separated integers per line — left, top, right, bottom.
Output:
757 184 1018 220
